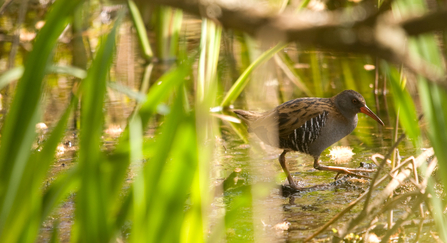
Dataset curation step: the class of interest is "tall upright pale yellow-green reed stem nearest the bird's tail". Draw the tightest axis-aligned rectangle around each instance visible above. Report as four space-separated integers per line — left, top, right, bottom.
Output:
185 20 222 243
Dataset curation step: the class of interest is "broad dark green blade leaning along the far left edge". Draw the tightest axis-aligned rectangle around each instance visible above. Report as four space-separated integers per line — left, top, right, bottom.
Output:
0 0 82 242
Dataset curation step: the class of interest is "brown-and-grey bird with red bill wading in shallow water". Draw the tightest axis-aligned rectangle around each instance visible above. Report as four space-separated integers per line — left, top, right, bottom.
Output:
233 90 385 190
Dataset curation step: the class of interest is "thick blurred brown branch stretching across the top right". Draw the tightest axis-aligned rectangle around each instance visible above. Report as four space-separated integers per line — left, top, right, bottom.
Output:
148 0 447 89
